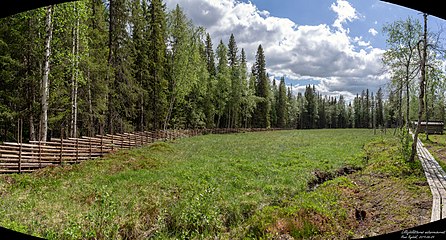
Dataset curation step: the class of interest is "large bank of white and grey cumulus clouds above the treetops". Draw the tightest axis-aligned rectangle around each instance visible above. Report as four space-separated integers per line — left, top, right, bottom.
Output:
166 0 385 101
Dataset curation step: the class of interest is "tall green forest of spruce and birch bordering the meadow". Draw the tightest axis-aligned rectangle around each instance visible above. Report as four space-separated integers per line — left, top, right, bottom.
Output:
0 0 445 141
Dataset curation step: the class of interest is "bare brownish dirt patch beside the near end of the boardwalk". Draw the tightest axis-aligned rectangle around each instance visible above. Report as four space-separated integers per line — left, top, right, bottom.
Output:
343 173 432 238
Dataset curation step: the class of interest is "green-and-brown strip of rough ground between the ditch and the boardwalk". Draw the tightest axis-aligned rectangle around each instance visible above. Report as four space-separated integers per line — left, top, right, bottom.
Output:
342 138 432 238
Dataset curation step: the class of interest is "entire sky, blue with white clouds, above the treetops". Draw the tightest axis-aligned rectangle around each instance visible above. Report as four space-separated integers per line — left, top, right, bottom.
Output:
165 0 446 101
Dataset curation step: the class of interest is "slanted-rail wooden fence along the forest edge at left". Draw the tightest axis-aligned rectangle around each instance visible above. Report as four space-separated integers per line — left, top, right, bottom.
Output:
0 128 277 173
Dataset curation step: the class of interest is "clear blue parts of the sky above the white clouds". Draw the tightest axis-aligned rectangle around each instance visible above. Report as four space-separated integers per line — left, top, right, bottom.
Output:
247 0 444 48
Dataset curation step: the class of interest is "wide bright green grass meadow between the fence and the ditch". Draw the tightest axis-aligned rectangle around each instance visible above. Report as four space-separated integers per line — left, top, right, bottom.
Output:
0 129 428 239
